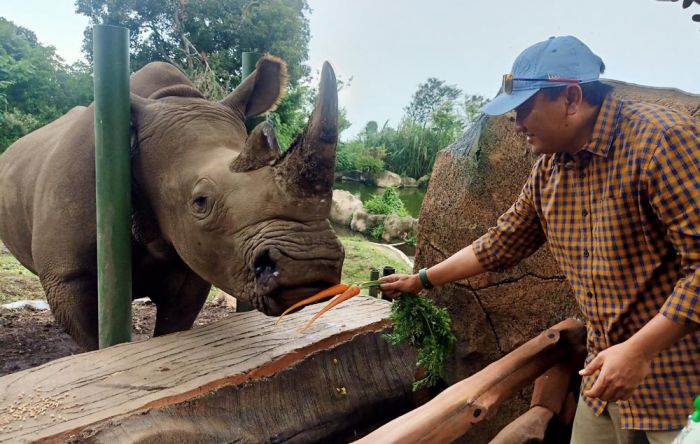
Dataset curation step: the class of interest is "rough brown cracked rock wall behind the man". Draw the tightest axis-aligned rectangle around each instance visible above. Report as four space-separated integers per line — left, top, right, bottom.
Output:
415 81 700 443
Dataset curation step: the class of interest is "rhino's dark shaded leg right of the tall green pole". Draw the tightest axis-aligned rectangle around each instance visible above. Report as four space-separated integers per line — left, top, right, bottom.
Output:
150 269 211 336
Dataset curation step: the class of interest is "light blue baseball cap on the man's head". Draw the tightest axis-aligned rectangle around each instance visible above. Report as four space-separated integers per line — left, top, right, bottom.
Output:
481 35 605 116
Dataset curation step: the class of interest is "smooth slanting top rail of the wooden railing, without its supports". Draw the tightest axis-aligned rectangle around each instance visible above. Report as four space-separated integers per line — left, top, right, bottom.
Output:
357 319 586 444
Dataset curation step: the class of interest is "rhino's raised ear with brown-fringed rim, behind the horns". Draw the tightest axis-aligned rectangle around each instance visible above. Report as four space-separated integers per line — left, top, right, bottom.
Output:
221 54 287 118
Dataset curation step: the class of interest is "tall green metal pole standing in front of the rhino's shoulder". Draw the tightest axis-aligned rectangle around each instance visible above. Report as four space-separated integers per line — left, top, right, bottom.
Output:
93 25 131 348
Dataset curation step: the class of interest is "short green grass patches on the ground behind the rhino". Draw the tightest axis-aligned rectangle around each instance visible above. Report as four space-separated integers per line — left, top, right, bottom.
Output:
0 236 411 305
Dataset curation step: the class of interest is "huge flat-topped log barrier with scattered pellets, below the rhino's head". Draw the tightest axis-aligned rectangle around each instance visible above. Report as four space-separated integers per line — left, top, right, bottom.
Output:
0 298 415 443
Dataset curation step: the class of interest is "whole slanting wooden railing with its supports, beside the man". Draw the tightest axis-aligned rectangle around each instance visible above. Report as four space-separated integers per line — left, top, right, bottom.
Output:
357 319 586 444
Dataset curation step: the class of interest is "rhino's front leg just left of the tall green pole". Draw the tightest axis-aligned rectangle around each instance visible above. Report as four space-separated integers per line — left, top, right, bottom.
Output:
39 274 99 350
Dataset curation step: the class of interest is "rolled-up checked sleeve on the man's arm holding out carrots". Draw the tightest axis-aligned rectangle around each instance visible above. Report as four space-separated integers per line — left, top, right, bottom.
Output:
472 158 547 271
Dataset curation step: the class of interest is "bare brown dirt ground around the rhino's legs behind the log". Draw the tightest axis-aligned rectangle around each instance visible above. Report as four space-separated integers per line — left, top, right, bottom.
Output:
0 302 234 376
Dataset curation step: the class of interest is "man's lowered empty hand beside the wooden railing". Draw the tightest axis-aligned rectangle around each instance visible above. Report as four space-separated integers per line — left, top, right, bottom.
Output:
579 342 651 401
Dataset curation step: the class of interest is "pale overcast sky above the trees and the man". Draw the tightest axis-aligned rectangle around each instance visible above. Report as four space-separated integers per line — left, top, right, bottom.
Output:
0 0 700 139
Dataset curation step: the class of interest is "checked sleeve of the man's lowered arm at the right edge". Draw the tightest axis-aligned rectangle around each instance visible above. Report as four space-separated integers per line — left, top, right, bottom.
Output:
647 123 700 324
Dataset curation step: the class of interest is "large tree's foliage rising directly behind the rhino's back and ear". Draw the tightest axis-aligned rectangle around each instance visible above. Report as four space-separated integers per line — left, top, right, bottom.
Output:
76 0 312 146
